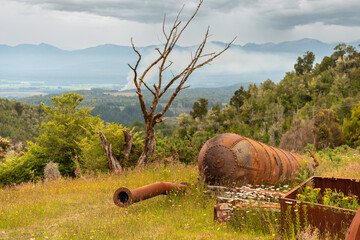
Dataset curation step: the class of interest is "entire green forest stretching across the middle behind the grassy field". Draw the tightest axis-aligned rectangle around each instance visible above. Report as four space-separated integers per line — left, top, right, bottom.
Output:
0 44 360 185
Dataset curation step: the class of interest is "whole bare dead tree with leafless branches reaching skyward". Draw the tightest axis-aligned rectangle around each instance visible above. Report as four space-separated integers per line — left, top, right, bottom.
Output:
129 0 235 166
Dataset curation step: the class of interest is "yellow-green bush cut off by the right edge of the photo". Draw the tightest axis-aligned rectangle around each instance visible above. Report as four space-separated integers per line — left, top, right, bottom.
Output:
344 102 360 147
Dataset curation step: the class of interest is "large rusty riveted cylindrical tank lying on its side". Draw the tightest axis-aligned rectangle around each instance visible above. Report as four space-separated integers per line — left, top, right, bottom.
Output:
198 133 314 185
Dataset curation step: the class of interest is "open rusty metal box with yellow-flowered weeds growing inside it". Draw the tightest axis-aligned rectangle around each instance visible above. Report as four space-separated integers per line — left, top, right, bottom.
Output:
280 177 360 235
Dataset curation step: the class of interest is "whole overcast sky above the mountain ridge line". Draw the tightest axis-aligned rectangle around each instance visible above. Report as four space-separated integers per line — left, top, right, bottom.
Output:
0 0 360 50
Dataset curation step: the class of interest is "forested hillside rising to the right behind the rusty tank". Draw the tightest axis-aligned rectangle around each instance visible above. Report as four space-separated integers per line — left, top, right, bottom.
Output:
176 44 360 150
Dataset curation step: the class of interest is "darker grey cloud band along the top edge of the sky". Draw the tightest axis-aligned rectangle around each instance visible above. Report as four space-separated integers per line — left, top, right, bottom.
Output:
13 0 360 28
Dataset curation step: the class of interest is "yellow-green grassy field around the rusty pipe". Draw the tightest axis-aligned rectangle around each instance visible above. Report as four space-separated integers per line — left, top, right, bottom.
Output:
0 145 360 239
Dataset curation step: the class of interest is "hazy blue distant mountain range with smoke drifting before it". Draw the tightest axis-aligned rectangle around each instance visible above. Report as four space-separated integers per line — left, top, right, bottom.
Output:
0 39 360 96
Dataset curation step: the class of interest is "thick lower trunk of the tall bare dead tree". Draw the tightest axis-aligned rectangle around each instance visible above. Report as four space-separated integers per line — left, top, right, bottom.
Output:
137 120 156 167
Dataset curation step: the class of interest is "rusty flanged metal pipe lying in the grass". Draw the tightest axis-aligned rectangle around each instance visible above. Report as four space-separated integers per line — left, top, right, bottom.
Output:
113 182 186 207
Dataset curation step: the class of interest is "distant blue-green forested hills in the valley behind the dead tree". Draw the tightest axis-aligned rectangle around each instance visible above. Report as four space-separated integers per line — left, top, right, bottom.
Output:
19 85 239 125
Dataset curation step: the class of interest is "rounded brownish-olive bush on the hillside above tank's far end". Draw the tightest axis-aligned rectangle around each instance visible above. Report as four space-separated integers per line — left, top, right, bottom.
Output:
312 109 345 149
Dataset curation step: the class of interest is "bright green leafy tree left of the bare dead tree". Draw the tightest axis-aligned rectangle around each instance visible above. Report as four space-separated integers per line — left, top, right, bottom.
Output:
34 93 102 176
